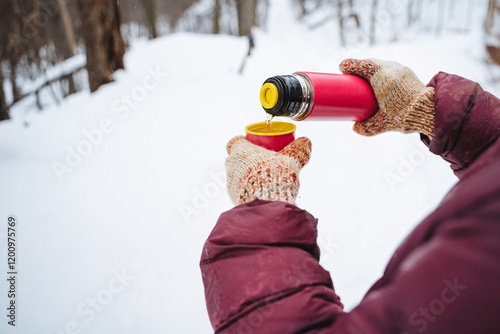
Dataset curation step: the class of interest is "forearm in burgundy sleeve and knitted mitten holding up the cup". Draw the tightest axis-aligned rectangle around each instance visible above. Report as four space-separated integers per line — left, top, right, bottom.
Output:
200 136 348 333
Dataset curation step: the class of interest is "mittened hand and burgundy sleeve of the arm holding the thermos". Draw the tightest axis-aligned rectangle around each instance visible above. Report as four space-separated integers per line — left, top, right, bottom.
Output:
340 59 500 178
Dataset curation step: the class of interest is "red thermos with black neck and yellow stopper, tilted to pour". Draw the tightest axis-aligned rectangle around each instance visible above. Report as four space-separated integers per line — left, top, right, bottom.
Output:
260 72 378 121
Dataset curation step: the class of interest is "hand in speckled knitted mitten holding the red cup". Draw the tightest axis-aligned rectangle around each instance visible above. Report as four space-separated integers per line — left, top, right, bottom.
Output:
226 136 311 205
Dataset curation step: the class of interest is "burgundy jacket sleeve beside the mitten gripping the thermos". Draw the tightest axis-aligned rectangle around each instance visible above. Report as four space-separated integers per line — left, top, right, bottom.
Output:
422 72 500 178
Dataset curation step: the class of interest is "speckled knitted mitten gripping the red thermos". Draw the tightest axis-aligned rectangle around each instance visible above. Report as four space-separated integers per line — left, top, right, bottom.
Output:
340 59 435 139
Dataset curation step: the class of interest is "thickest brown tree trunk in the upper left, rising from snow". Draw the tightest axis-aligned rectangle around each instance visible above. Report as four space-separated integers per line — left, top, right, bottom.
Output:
77 0 125 92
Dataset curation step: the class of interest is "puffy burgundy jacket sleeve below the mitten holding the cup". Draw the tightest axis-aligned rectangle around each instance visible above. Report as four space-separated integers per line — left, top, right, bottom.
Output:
201 200 342 334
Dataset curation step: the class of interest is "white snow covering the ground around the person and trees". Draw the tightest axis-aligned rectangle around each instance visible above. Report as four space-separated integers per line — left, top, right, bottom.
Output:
0 0 492 334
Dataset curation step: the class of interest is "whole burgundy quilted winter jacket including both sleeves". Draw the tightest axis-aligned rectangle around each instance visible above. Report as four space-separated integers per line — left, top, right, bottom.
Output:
201 73 500 334
